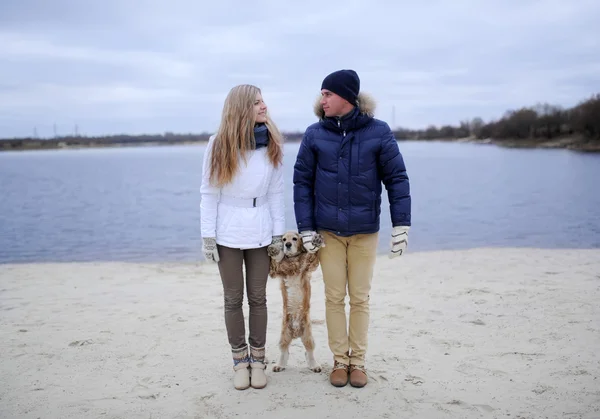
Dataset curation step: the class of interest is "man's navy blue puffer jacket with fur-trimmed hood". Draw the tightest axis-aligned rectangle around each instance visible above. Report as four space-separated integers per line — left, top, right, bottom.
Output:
293 93 411 236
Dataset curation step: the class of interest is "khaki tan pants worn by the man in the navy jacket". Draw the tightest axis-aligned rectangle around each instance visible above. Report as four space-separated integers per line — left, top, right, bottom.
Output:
319 231 378 366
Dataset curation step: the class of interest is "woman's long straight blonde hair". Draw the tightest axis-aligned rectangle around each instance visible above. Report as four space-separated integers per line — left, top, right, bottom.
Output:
209 84 283 187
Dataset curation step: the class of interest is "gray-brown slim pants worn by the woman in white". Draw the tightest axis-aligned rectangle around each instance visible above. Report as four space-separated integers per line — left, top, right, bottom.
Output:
217 245 270 349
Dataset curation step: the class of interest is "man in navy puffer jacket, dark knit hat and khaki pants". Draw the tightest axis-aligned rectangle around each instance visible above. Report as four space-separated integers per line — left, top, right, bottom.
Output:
293 70 411 387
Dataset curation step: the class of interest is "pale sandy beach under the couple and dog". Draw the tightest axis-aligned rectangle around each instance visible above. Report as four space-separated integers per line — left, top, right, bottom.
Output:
0 249 600 419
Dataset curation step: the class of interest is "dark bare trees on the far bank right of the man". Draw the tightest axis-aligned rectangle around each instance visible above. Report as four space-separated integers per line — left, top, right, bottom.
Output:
394 94 600 142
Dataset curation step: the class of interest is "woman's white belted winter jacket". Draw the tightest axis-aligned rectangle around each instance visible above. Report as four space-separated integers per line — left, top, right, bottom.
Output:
200 135 285 249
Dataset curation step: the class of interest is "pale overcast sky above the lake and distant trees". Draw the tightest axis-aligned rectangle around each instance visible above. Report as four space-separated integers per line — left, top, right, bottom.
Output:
0 0 600 137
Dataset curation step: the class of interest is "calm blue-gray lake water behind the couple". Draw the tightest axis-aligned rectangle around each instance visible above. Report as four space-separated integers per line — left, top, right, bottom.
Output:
0 142 600 263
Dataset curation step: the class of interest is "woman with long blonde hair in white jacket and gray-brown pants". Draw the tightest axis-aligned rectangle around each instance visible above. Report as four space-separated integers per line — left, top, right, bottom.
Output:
200 85 285 389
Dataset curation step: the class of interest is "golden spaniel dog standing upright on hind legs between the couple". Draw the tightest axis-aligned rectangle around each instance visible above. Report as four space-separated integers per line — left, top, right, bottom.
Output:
269 231 324 372
